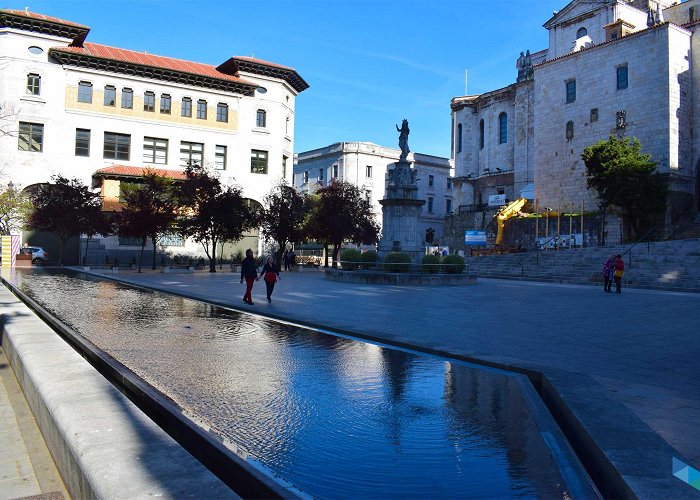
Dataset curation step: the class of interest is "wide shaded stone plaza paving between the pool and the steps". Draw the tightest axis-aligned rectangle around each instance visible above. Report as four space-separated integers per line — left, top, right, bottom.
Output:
90 271 700 478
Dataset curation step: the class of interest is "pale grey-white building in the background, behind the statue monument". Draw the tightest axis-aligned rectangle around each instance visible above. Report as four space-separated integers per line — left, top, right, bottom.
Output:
293 142 455 245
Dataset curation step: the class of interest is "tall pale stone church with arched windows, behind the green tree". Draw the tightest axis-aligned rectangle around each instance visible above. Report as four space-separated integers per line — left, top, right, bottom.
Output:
451 0 700 241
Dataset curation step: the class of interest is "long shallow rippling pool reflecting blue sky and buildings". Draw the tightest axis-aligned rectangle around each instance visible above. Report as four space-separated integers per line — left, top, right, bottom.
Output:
12 269 566 498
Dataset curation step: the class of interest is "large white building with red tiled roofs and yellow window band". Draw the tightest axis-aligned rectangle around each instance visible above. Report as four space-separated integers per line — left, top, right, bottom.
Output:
0 10 308 262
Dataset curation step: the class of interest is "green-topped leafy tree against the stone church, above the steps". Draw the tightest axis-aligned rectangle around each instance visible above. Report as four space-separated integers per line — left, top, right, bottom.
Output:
581 136 668 235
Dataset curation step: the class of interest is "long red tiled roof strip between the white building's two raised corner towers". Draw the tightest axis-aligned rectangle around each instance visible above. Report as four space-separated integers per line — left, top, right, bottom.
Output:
51 42 256 86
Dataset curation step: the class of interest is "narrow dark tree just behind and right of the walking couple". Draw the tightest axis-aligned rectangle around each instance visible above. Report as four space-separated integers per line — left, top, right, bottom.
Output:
261 179 307 269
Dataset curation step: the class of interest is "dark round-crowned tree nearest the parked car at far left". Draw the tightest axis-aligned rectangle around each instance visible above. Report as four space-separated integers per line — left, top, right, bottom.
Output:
27 175 103 266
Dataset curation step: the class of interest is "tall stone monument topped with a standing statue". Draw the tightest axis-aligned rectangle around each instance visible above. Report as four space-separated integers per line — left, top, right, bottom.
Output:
377 119 425 264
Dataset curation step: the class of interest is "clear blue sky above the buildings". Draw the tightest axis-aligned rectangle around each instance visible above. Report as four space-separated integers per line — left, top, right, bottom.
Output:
13 0 568 156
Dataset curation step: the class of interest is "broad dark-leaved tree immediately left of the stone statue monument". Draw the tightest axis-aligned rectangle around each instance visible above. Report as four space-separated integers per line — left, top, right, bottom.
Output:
304 181 379 267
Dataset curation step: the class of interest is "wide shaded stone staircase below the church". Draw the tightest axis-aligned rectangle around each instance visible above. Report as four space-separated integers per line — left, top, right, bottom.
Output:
465 238 700 292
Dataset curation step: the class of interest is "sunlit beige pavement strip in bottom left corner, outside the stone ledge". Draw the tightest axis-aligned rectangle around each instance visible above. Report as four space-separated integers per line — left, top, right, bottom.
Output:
0 348 70 500
